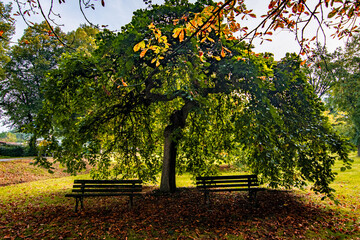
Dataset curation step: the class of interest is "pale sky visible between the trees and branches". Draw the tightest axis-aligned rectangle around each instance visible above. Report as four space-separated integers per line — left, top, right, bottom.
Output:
0 0 344 132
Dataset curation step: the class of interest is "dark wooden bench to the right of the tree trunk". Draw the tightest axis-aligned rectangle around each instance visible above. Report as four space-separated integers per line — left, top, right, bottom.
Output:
196 175 264 203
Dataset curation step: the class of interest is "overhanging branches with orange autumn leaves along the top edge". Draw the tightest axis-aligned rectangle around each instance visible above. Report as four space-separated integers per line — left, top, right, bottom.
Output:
11 0 360 54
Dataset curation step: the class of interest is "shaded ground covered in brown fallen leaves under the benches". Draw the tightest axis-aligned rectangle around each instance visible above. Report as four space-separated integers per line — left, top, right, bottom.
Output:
0 188 360 239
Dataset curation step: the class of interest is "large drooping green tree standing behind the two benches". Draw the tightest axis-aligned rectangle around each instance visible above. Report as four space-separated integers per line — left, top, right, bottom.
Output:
35 1 349 197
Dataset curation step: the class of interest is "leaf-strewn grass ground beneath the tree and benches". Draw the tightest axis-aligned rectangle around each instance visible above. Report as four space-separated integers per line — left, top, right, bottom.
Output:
0 156 360 239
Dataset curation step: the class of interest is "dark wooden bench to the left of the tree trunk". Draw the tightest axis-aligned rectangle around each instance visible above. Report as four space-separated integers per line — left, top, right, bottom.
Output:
65 180 142 212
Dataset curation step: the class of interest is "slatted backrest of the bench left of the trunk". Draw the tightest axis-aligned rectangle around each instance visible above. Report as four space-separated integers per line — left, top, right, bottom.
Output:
72 180 142 194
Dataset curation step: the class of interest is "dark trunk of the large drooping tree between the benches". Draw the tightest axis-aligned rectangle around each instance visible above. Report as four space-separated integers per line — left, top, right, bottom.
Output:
160 101 195 193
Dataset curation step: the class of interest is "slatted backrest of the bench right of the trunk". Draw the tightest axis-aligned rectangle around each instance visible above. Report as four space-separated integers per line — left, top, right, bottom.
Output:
196 175 259 190
